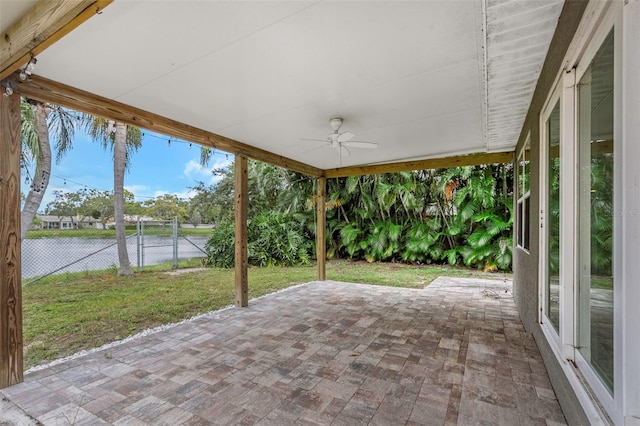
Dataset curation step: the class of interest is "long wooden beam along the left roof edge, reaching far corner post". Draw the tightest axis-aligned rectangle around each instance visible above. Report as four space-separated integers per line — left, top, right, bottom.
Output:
17 76 322 177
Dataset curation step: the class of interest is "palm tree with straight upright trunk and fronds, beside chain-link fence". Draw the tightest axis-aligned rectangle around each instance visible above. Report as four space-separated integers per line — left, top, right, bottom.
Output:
83 115 142 275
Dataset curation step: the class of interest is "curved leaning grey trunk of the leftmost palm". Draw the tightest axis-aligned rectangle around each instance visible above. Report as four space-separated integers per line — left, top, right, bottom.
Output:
20 102 51 240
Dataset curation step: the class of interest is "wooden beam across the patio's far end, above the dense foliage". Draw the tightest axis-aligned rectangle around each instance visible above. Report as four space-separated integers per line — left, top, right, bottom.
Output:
324 151 514 178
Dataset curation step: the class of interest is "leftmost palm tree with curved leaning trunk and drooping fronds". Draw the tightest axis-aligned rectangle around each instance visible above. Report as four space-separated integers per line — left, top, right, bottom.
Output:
20 98 76 239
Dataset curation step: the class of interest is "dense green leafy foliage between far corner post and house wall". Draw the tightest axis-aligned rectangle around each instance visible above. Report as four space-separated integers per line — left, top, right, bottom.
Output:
327 165 513 270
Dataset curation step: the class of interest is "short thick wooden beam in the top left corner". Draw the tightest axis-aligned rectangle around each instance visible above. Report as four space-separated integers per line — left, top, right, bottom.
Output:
0 0 113 80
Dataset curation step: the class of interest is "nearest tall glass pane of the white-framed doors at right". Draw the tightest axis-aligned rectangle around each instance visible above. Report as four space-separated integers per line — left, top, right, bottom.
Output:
577 30 615 392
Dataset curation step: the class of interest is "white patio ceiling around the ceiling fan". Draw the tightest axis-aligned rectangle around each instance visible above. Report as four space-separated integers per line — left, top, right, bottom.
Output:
0 0 562 169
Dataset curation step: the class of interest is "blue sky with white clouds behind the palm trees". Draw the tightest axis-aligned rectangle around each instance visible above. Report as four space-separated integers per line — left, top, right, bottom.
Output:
22 131 233 210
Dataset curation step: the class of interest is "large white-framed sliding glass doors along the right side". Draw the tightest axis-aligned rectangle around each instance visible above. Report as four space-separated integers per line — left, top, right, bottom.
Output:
532 2 640 424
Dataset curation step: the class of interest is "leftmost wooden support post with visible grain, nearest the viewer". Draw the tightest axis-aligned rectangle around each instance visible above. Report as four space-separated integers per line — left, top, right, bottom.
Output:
0 90 23 389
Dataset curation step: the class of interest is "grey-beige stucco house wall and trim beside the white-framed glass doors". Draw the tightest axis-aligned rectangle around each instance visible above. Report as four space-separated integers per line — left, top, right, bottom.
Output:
513 0 589 425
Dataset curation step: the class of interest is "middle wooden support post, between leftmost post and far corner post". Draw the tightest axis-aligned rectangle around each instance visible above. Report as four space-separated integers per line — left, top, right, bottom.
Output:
235 155 249 308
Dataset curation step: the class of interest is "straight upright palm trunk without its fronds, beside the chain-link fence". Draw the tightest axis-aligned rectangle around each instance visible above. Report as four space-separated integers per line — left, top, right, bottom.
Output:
113 123 133 275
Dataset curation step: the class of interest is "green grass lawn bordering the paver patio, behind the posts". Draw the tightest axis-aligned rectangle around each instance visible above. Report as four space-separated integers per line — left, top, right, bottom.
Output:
23 260 504 368
